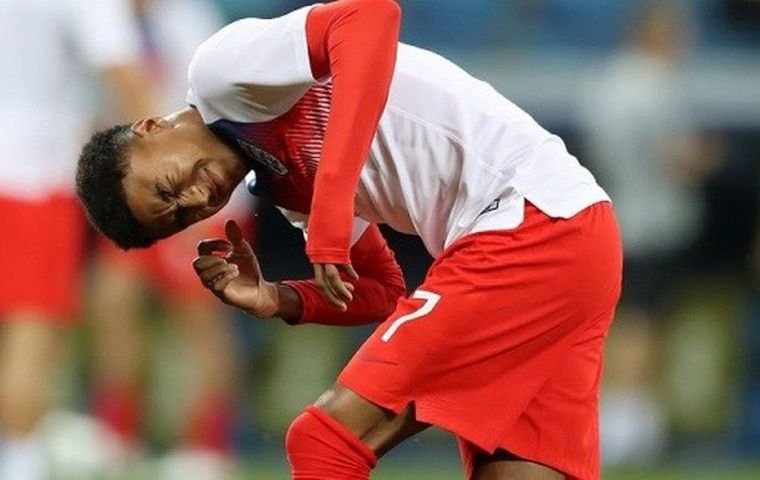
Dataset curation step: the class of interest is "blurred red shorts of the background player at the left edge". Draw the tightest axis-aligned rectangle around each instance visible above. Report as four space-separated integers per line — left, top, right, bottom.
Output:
0 194 85 323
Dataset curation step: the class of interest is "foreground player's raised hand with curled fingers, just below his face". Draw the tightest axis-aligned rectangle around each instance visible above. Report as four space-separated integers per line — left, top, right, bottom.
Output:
193 220 278 318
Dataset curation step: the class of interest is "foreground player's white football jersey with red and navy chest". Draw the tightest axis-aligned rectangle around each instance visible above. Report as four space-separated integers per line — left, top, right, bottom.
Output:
188 7 609 256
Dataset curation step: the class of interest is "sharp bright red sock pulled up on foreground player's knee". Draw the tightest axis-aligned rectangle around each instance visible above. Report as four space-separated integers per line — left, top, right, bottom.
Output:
285 406 377 480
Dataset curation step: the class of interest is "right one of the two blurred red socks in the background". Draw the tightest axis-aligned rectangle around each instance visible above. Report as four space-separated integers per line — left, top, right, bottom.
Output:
185 395 233 454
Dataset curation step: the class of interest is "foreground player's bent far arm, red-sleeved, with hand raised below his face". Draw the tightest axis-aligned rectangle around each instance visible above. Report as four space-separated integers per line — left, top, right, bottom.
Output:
193 221 406 325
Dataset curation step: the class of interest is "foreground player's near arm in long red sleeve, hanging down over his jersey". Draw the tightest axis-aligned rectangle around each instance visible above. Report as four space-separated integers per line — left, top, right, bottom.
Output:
306 0 401 294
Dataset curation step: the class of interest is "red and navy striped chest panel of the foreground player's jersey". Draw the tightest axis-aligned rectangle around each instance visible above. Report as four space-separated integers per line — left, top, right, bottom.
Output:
209 83 332 213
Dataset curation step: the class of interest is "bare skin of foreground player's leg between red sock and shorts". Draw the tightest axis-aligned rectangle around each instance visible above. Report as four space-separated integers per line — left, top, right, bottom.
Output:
315 383 430 457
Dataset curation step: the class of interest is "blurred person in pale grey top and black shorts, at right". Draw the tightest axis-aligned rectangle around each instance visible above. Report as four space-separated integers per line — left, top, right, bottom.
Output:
581 1 713 464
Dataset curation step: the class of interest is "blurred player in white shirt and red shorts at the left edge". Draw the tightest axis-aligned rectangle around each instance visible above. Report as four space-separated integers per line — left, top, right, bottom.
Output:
0 0 155 480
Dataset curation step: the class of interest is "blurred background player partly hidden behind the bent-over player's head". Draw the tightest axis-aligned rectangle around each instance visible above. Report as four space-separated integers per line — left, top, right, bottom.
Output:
84 0 253 480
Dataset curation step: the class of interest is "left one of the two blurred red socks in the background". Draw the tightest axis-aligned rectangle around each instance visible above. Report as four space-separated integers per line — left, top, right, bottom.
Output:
92 384 140 444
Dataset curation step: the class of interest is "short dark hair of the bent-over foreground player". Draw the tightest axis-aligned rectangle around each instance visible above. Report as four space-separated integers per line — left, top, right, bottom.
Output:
76 125 155 250
